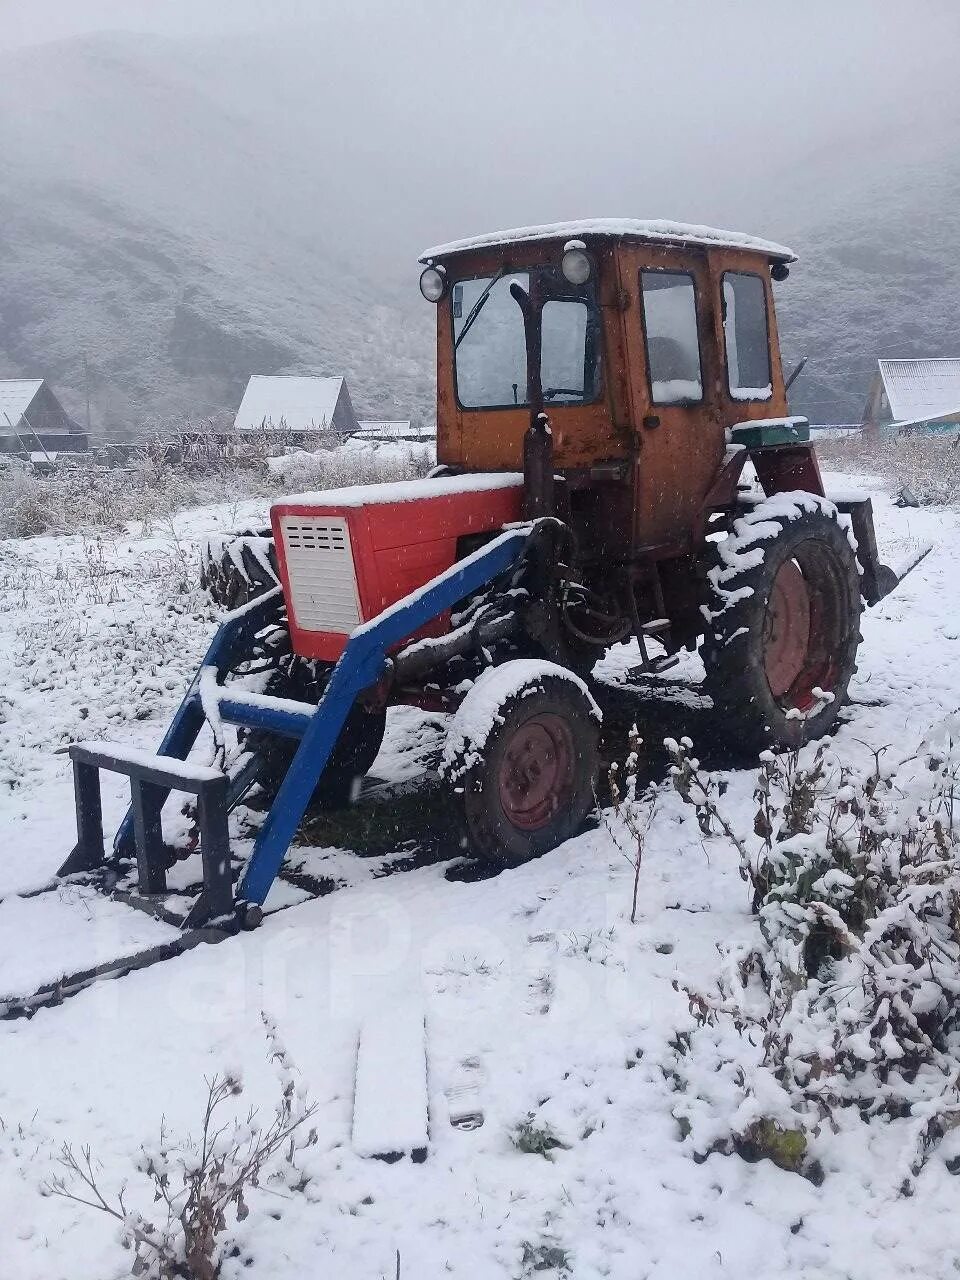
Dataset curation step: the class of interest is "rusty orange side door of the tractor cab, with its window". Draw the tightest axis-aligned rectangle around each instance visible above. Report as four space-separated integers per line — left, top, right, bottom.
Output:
622 244 724 554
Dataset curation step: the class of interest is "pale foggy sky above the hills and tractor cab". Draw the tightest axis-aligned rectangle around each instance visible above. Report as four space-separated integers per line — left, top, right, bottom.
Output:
0 0 960 271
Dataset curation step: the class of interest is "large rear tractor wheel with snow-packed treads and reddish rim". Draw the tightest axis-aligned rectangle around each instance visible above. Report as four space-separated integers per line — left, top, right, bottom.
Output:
701 493 861 750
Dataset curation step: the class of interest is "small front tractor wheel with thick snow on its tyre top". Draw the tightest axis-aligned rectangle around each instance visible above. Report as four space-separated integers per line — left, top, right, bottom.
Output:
443 658 600 863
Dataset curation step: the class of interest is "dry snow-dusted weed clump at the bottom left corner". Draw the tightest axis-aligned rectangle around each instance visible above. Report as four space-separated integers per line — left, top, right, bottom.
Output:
41 1015 316 1280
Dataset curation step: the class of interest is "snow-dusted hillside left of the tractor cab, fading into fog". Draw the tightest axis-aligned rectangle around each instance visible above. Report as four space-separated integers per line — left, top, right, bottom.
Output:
0 37 433 435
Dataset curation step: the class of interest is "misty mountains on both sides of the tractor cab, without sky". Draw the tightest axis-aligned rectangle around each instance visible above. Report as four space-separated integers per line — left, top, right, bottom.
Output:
0 17 960 436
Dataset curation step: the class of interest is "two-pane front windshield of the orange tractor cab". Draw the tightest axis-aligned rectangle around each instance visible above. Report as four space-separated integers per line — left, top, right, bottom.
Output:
452 268 600 408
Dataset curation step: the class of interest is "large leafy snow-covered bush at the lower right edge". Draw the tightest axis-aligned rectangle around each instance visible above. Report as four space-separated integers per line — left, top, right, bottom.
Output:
675 716 960 1172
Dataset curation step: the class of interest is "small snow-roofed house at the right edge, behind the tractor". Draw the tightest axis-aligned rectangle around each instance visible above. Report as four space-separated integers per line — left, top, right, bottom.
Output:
863 360 960 431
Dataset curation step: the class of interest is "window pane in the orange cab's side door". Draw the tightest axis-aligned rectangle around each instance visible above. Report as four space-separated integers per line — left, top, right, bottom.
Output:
640 270 703 404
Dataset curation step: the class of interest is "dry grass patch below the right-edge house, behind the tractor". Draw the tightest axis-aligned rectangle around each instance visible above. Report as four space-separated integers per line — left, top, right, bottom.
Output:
817 431 960 504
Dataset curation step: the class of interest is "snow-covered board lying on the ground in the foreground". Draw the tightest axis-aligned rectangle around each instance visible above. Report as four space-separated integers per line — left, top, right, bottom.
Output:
353 1000 428 1161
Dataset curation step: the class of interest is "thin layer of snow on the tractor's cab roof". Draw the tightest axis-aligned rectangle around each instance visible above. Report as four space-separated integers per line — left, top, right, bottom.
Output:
420 218 796 262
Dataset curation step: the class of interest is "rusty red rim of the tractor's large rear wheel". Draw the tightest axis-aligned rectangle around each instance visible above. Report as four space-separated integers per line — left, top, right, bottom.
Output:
763 539 849 712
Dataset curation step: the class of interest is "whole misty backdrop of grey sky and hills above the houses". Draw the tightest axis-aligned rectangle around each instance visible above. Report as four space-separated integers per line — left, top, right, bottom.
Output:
0 0 960 435
